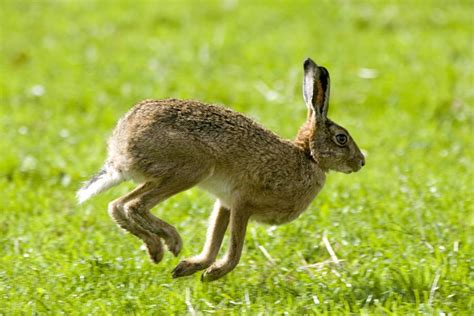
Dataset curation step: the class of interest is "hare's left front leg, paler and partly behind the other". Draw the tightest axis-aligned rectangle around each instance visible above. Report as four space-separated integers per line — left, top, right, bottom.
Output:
172 200 230 278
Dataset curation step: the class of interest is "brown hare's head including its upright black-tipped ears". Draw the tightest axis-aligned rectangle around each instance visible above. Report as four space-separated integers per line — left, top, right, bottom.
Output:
303 58 365 173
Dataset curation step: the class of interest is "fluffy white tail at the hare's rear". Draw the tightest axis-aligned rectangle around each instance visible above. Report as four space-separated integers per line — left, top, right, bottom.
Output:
76 164 127 204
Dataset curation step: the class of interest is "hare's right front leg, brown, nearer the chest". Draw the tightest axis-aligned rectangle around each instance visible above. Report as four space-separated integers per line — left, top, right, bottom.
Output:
201 207 250 282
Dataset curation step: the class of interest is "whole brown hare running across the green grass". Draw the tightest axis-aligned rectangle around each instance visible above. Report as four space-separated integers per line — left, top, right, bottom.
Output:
77 58 365 281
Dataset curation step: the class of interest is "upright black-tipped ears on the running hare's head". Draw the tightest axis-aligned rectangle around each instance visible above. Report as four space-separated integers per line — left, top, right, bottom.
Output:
303 58 330 118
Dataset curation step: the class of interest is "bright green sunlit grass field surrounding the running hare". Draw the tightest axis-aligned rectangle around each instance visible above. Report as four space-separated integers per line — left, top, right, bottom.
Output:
0 0 474 315
